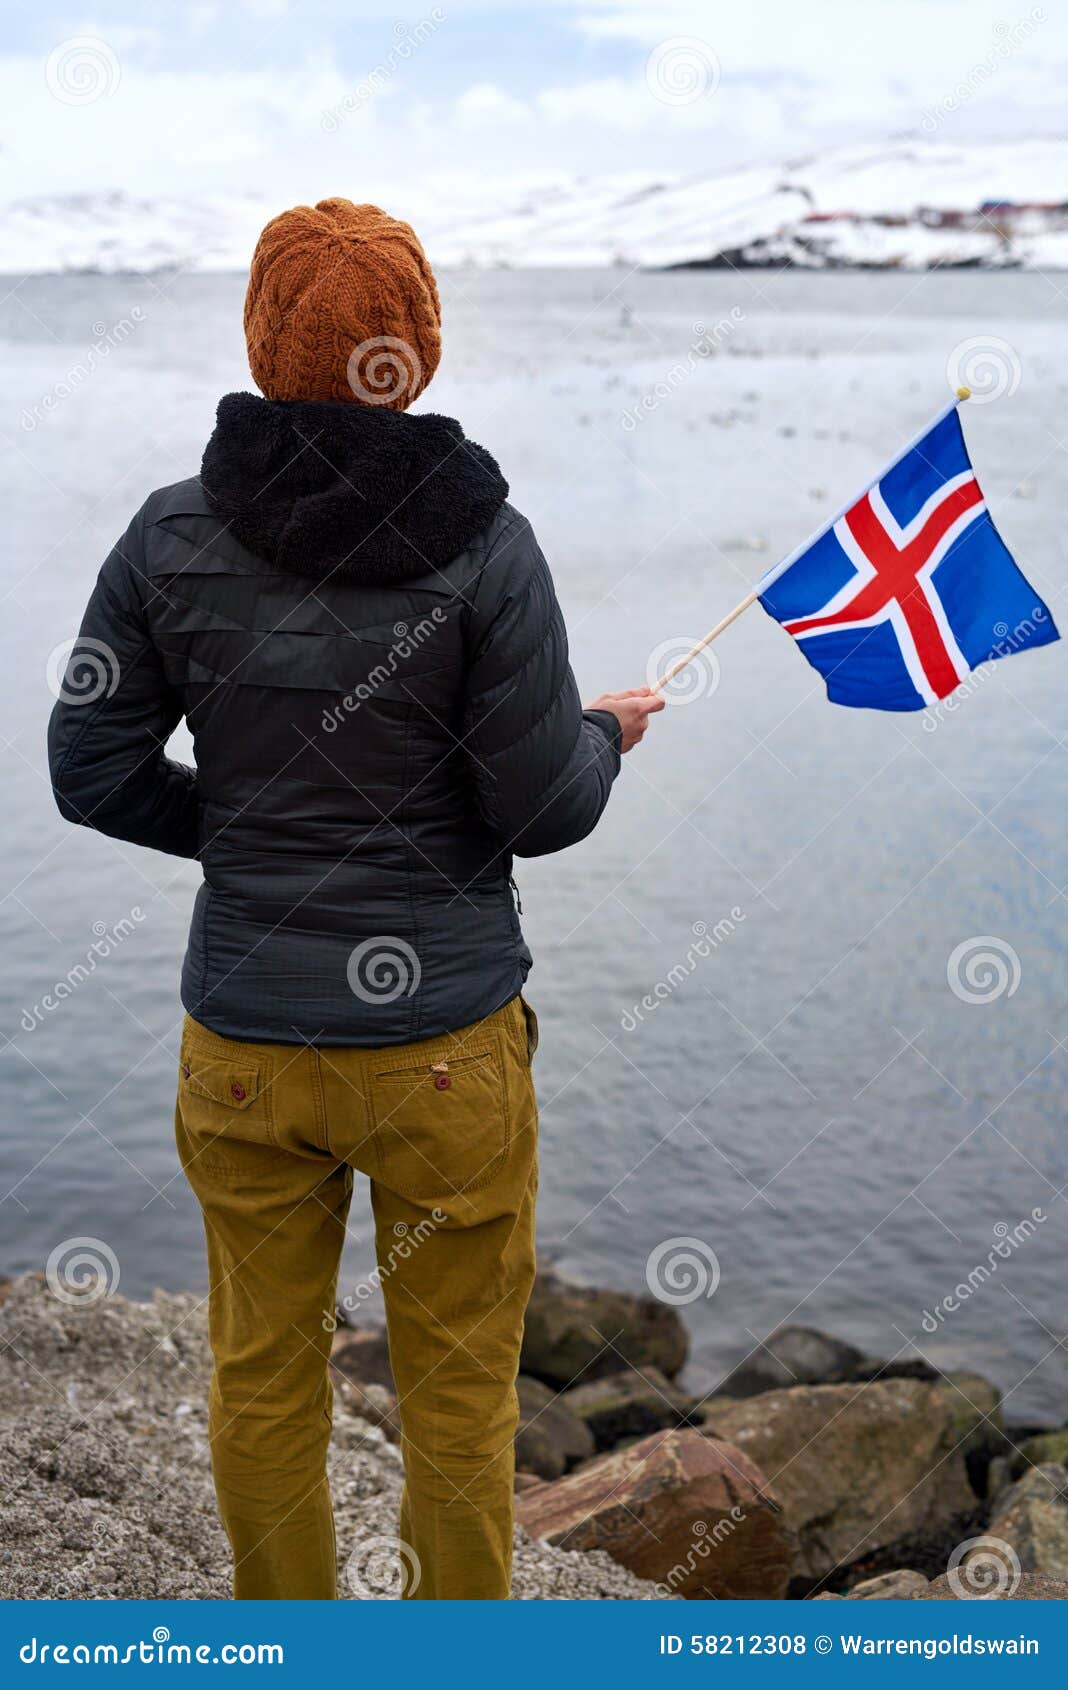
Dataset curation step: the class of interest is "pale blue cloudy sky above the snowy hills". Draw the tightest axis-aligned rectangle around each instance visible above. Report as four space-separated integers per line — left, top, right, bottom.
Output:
8 0 1068 199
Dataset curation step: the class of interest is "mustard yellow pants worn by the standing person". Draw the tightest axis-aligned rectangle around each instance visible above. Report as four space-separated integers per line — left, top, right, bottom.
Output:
176 997 537 1599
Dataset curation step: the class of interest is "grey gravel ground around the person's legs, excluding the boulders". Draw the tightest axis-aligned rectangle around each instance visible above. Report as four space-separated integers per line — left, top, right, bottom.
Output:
0 1274 656 1600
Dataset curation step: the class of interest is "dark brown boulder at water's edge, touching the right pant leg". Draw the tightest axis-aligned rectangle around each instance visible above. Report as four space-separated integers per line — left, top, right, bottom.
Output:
520 1273 688 1387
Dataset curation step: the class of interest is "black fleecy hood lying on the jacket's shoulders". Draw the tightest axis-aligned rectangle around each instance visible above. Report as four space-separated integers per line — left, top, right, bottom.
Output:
201 394 509 583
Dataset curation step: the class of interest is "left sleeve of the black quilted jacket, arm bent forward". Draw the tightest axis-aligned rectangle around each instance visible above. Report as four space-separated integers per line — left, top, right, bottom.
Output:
49 510 198 857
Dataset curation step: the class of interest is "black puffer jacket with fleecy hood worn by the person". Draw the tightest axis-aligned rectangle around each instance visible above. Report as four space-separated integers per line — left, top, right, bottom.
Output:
49 394 620 1044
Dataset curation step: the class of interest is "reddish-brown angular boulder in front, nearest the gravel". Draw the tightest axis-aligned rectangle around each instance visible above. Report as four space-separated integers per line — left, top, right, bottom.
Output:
517 1430 794 1599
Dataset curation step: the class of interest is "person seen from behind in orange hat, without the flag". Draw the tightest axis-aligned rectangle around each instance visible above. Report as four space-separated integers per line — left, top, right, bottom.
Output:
49 199 662 1599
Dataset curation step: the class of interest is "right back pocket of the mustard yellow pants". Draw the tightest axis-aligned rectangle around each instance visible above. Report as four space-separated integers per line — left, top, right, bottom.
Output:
372 1046 510 1200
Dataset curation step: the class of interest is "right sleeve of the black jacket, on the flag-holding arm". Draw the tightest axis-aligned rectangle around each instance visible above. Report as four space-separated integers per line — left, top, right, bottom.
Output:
463 512 622 857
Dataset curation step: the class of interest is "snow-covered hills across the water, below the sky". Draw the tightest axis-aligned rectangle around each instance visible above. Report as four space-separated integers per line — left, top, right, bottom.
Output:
0 140 1068 274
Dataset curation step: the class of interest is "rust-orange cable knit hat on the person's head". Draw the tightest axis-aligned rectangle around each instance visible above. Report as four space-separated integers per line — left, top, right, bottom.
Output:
245 199 441 411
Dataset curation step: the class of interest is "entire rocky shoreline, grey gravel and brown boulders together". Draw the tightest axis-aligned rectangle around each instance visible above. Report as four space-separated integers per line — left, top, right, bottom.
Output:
0 1273 1068 1600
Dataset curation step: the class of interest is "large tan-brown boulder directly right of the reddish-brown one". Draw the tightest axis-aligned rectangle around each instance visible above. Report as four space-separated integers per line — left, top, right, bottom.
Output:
705 1379 975 1580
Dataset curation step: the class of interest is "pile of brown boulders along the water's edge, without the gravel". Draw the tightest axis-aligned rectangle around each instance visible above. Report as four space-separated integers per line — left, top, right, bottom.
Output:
335 1273 1068 1599
